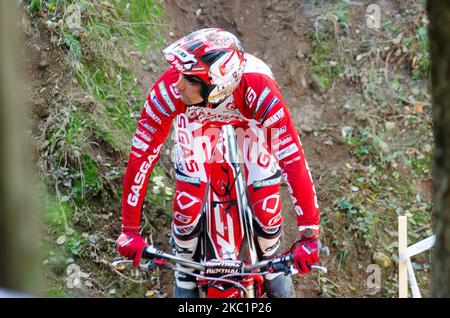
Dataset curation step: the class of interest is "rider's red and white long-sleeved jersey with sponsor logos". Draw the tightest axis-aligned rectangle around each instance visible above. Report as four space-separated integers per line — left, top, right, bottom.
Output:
122 53 320 232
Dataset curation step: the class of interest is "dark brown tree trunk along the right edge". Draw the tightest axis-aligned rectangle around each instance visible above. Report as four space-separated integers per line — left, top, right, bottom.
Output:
427 0 450 297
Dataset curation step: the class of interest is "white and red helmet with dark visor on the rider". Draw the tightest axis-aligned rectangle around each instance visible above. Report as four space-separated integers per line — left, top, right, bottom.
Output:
163 28 245 104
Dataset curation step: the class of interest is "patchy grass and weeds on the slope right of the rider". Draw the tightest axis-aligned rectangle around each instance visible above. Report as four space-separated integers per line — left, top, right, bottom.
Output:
308 1 432 297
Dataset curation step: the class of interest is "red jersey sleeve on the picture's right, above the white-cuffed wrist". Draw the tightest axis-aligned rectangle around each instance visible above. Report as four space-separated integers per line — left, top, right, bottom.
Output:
239 73 320 230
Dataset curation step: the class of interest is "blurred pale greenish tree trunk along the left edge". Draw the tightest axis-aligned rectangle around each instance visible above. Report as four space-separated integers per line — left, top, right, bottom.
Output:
0 1 39 295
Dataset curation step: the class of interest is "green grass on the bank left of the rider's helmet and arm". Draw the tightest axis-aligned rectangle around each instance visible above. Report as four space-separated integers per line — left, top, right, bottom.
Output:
27 0 166 202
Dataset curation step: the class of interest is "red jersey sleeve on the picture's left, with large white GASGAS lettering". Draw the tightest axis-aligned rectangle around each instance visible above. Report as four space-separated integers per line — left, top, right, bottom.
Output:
122 68 186 232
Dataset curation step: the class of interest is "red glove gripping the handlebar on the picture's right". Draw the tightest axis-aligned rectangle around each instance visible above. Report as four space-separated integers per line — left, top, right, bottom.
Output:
291 226 320 274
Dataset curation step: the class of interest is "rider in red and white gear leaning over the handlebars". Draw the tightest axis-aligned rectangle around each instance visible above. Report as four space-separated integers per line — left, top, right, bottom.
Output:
117 28 320 298
